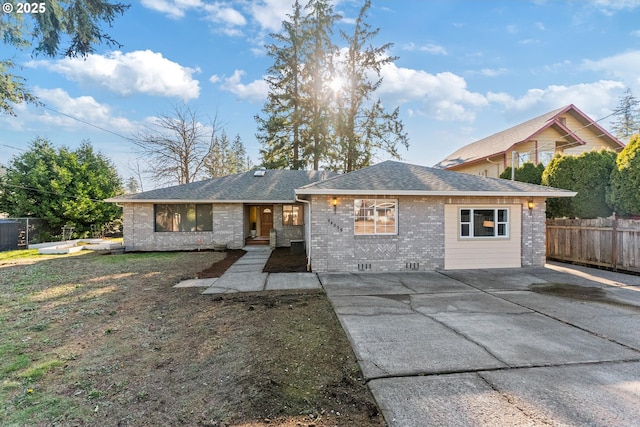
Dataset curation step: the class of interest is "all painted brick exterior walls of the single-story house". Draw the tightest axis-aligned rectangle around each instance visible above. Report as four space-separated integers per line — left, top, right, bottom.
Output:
123 196 546 272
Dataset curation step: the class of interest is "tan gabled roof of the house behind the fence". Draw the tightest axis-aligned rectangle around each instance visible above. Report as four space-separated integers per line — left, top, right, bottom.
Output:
435 104 624 169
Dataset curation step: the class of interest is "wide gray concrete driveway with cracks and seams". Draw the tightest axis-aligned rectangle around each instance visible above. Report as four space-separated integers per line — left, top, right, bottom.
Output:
319 266 640 427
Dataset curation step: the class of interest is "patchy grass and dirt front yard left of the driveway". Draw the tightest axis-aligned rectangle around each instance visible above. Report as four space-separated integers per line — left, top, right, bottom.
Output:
0 252 384 427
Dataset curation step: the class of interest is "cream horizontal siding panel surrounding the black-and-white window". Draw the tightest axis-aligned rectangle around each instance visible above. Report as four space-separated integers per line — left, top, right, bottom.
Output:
444 204 522 270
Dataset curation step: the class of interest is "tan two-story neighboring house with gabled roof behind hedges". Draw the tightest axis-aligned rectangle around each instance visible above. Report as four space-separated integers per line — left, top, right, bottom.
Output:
435 105 624 178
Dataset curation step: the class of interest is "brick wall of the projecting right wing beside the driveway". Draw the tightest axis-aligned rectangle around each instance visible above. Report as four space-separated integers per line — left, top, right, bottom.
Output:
311 196 546 272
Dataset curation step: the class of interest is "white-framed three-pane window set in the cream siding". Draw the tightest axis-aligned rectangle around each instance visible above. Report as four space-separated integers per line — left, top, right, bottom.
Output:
460 209 509 238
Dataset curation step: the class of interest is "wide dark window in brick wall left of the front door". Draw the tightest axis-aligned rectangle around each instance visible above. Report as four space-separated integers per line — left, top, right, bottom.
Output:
154 203 213 232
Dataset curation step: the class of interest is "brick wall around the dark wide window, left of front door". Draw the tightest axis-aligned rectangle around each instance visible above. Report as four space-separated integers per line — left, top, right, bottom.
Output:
123 203 245 251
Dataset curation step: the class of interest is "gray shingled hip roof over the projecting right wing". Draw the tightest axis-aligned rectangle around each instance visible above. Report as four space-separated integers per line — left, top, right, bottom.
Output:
296 160 576 197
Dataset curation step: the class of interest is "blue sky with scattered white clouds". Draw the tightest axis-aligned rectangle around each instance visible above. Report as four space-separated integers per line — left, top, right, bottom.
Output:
0 0 640 189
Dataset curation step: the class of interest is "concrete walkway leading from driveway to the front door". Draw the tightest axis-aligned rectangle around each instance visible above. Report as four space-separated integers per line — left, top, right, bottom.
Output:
203 246 321 294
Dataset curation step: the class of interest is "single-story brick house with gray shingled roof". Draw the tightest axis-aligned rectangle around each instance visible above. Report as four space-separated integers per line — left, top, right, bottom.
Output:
108 161 576 272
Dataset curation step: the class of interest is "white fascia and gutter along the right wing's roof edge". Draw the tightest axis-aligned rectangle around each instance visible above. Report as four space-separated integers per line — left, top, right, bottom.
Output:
296 189 578 197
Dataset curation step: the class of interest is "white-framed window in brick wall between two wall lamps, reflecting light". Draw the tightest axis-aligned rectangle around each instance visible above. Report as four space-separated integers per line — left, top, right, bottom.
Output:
353 199 398 235
